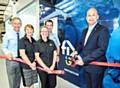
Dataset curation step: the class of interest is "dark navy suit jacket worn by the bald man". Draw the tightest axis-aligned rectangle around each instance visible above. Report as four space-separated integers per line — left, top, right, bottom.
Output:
77 23 109 72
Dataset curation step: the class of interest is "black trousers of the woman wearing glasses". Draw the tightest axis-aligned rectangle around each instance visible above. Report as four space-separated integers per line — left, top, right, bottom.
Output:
38 71 56 88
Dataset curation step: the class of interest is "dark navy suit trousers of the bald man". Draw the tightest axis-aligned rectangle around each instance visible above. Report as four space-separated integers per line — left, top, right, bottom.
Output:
85 71 104 88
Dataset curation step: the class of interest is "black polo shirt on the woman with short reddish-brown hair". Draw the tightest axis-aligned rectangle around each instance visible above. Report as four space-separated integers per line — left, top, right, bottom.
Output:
19 36 36 69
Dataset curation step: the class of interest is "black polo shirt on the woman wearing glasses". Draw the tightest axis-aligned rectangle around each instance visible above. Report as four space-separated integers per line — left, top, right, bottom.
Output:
35 39 57 67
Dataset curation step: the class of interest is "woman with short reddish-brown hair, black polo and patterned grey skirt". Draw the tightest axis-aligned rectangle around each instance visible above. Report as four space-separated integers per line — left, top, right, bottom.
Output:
19 24 38 88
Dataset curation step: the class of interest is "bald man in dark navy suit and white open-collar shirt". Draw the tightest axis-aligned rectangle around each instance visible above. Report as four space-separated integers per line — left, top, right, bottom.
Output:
73 8 109 88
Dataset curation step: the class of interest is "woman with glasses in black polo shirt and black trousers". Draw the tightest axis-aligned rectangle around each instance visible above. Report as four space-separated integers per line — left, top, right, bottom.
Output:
35 27 57 88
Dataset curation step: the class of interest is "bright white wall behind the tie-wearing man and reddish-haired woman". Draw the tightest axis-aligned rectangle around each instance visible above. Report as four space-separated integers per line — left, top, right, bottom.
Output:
5 0 39 40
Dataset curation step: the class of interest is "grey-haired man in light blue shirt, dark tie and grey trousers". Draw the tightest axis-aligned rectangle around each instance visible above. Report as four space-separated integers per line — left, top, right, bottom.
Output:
2 17 22 88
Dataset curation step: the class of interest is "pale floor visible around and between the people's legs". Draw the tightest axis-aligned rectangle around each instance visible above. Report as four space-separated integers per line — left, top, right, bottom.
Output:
0 44 79 88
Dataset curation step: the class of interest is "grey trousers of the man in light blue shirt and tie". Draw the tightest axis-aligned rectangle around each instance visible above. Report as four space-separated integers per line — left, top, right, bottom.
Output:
6 60 21 88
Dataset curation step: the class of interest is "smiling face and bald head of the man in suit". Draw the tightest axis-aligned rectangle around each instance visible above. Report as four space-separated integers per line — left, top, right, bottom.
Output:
86 8 99 26
